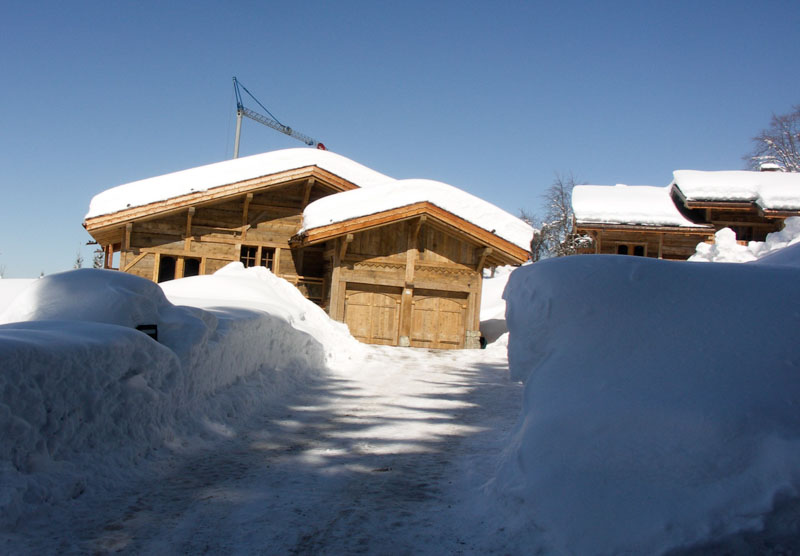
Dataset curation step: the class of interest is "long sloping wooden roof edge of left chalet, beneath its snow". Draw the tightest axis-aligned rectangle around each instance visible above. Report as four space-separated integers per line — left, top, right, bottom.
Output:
83 166 358 236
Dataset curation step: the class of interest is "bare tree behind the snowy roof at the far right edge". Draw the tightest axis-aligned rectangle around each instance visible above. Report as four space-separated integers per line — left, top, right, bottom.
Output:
744 104 800 172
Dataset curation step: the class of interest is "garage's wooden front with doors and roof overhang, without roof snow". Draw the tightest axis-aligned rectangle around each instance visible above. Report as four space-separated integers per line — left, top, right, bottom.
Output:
293 203 528 349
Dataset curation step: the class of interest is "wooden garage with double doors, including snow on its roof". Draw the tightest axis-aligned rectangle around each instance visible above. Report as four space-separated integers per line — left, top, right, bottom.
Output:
293 180 533 349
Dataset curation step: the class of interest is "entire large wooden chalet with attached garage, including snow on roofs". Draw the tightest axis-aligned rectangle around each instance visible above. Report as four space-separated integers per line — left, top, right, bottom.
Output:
84 149 532 348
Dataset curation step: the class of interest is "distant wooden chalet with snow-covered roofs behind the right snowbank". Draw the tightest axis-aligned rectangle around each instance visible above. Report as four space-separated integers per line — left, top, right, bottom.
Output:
573 170 800 260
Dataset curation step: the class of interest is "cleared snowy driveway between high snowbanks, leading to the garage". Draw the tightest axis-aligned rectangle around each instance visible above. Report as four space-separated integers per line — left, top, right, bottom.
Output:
14 346 522 554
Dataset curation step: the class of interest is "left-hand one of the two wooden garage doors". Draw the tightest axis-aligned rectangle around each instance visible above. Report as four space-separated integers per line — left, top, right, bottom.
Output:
344 284 402 346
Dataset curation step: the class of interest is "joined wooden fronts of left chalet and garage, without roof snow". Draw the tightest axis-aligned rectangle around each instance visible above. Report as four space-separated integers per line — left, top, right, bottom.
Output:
84 166 528 349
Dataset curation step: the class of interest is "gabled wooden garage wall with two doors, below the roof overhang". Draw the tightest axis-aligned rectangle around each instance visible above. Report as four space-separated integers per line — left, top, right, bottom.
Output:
326 218 482 349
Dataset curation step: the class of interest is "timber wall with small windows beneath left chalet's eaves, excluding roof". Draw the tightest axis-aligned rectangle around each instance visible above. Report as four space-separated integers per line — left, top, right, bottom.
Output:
112 180 332 296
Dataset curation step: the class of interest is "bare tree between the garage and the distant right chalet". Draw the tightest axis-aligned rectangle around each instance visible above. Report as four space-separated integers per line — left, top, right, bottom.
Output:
521 174 590 261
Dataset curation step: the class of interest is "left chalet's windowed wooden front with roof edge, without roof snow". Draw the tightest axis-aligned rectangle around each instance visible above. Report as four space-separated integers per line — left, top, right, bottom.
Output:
84 166 356 303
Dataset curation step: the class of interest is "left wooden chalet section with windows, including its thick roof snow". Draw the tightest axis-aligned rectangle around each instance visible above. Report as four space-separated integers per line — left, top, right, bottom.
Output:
84 148 391 302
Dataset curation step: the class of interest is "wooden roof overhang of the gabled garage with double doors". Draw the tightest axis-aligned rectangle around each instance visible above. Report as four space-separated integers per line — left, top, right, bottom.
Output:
291 201 529 264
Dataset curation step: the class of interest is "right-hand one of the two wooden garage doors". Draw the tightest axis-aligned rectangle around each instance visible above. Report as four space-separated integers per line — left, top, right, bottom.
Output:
410 291 467 349
